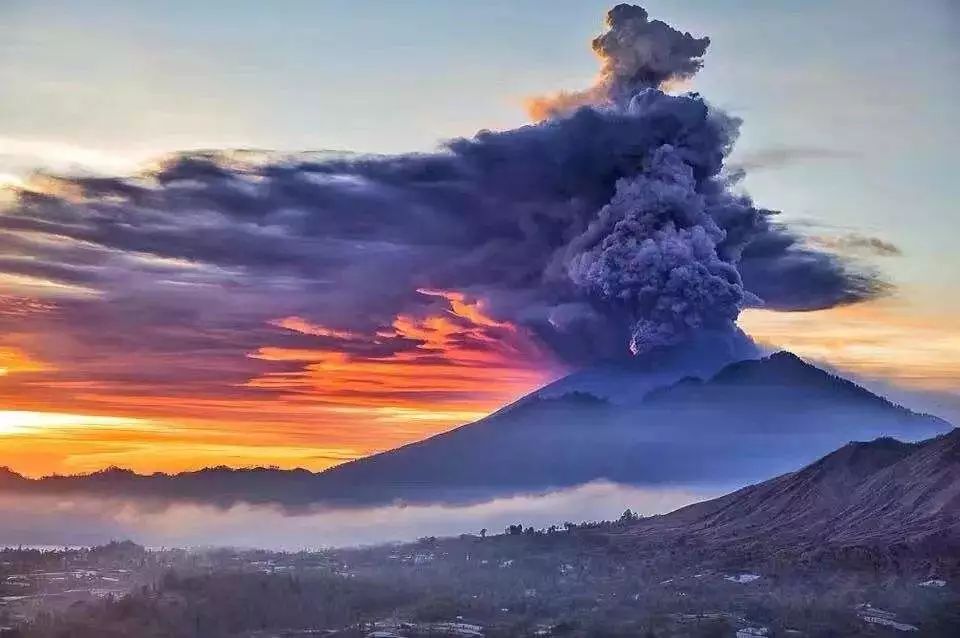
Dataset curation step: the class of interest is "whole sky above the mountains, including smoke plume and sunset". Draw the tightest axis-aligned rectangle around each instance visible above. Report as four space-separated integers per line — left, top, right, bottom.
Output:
0 3 960 484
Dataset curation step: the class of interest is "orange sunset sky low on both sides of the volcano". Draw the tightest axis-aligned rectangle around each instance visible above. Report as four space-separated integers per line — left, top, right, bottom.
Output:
0 291 960 476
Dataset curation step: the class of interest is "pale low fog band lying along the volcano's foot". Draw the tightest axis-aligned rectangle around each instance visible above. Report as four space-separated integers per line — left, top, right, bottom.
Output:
0 482 719 550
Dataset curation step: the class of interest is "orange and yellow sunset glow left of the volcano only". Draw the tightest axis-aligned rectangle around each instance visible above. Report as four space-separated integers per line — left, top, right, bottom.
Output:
0 291 563 476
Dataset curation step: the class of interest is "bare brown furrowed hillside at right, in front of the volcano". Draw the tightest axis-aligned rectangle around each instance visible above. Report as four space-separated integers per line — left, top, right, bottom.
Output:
627 430 960 556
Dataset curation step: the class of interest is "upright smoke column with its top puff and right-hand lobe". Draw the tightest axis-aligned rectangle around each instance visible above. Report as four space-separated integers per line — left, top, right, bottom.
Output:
531 4 879 354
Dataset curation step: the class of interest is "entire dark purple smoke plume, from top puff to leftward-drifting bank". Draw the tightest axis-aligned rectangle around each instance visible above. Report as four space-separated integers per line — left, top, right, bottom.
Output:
0 5 882 370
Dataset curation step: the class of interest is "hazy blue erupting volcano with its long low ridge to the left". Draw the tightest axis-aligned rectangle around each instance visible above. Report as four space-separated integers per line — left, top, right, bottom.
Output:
0 352 951 505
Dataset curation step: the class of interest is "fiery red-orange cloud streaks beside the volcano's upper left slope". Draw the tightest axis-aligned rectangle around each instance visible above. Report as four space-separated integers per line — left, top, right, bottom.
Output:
247 290 558 418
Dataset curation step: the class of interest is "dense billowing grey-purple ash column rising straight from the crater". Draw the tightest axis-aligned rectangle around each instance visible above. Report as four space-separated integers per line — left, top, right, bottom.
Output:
569 146 746 354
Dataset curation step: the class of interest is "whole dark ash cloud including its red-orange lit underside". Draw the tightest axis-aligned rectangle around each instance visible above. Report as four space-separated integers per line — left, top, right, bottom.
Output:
0 5 885 450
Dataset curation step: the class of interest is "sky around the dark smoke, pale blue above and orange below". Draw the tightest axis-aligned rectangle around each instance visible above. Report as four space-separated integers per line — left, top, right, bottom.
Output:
0 0 960 476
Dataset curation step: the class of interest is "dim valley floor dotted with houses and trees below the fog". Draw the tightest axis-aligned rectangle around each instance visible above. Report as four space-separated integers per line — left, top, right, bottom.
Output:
0 523 960 638
